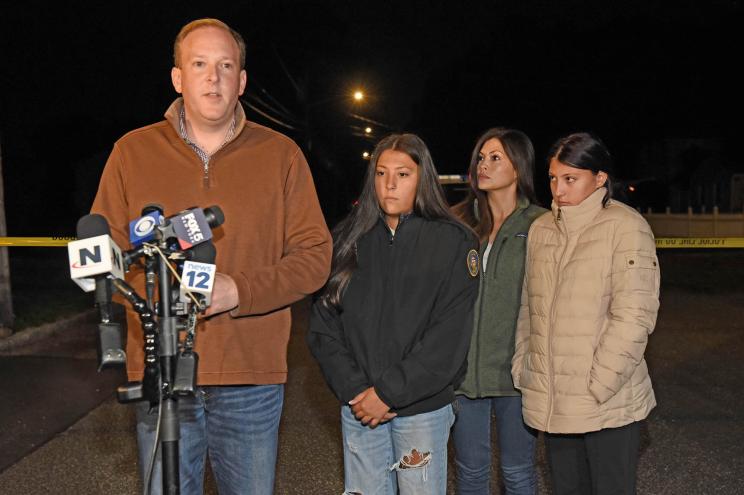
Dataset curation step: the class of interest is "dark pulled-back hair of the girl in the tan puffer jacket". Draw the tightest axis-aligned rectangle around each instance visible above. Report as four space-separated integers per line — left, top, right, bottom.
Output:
548 132 614 208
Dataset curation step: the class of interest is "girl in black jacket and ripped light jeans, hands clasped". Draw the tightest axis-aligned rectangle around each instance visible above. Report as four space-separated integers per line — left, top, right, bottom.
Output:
308 134 479 495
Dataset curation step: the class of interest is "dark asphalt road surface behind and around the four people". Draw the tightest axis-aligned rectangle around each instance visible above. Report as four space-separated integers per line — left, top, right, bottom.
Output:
0 290 744 495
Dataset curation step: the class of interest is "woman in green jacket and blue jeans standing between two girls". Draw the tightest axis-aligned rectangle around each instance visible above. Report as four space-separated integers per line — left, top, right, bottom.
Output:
453 128 547 495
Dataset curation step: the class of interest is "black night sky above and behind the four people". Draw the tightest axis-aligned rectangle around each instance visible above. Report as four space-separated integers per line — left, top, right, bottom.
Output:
0 0 744 235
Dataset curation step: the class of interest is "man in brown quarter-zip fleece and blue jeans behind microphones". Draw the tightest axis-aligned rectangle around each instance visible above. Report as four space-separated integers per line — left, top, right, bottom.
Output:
92 19 332 494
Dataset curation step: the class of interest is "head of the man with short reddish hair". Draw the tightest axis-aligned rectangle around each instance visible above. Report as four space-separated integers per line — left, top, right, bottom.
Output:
171 26 246 130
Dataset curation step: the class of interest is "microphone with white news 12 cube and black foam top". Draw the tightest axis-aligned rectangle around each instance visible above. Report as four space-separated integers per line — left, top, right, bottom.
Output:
179 241 217 310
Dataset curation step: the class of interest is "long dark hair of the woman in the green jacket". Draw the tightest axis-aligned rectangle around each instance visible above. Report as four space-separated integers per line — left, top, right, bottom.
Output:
452 127 537 241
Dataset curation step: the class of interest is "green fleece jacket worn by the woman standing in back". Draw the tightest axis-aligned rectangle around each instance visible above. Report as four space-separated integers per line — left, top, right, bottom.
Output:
457 198 547 399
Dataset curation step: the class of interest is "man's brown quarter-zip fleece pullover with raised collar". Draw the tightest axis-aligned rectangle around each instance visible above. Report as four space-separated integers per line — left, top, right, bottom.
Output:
92 98 332 385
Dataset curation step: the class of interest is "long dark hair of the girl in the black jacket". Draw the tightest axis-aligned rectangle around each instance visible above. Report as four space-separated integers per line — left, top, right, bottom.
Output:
320 134 457 309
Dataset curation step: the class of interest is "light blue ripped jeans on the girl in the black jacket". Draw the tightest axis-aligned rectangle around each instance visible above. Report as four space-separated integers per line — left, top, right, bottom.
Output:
341 404 455 495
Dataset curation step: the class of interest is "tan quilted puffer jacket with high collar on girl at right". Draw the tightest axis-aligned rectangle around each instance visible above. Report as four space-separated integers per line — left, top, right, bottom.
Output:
512 188 659 433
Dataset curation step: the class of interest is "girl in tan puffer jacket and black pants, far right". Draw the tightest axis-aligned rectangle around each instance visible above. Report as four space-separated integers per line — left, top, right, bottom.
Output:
512 133 659 495
